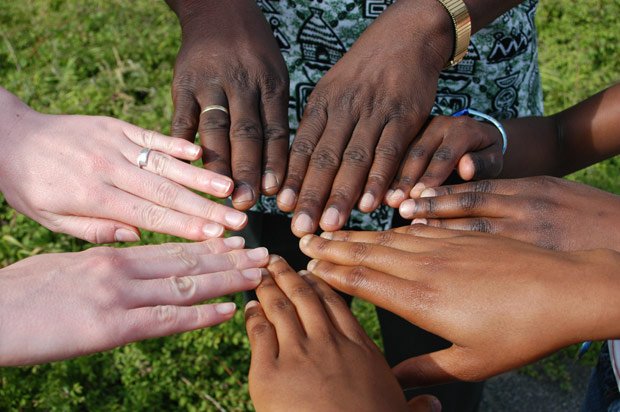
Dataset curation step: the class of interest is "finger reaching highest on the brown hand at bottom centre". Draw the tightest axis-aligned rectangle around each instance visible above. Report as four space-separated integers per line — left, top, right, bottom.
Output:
267 256 334 337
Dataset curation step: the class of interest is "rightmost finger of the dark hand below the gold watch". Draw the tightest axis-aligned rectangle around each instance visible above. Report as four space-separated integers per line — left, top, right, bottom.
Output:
364 119 414 207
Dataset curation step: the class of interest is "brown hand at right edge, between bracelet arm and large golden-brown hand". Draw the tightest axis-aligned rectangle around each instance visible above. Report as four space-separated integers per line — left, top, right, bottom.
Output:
400 177 620 250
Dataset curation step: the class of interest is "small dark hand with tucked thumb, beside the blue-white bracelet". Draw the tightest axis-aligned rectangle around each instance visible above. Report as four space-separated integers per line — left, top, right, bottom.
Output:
386 116 503 200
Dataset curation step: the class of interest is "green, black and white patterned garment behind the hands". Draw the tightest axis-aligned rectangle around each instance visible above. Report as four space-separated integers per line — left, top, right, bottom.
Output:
254 0 543 230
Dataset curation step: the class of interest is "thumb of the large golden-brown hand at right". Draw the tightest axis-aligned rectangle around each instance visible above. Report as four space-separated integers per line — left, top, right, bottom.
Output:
392 346 473 388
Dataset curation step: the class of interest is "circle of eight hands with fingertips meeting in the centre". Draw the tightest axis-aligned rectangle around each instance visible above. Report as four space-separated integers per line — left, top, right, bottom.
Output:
0 2 613 410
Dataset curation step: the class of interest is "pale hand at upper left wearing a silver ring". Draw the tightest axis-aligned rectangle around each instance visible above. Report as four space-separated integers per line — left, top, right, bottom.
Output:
0 98 247 243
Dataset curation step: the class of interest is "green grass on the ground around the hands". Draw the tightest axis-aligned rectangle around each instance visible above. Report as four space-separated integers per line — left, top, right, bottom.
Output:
0 0 620 411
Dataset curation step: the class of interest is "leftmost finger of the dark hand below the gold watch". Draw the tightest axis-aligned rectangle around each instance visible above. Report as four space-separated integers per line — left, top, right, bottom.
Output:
277 89 328 212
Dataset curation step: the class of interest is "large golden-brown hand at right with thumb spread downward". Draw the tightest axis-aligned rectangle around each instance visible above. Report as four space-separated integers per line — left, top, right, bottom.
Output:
300 225 620 386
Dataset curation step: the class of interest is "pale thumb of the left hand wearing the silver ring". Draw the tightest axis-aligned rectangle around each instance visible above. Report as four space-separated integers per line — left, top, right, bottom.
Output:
50 216 140 243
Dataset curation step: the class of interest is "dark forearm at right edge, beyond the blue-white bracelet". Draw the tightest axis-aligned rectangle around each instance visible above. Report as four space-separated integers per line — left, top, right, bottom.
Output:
500 85 620 178
